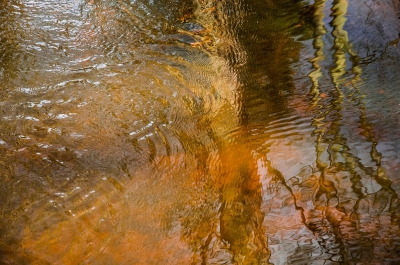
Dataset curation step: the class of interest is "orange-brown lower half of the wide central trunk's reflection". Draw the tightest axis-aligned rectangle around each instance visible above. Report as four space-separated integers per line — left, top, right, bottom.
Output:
219 144 270 264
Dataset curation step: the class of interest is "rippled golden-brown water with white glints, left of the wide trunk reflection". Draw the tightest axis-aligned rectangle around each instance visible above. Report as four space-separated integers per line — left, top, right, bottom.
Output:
0 1 228 264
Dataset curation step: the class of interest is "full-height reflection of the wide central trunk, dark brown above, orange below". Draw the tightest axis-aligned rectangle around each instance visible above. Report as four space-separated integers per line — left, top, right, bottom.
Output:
179 1 306 264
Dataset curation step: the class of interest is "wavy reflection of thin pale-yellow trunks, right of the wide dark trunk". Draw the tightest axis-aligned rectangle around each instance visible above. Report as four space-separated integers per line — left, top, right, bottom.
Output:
306 1 397 263
